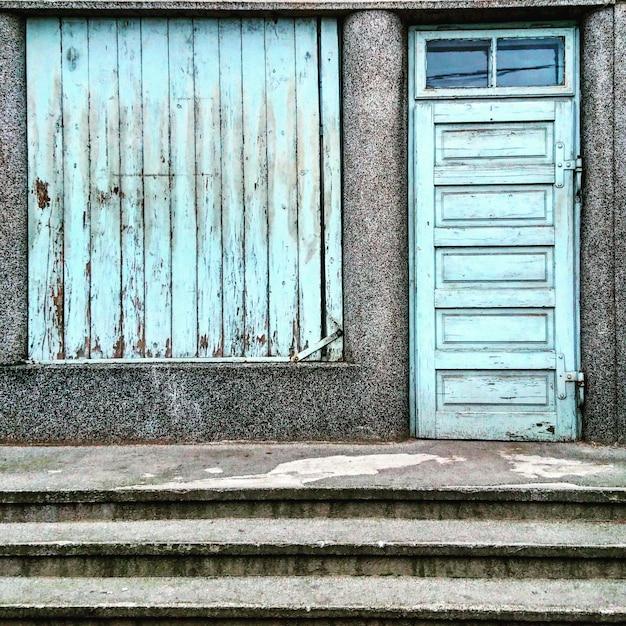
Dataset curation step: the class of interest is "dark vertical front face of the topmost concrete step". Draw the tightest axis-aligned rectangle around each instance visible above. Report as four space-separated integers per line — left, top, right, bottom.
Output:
0 483 626 522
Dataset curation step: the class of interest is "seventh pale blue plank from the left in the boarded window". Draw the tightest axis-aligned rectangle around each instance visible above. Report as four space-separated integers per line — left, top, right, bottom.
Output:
194 19 224 357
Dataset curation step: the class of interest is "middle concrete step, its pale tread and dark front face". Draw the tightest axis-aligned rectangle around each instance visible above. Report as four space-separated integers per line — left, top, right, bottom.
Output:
0 518 626 579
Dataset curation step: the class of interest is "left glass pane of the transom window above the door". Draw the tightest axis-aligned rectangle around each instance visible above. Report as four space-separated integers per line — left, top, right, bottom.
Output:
426 39 491 89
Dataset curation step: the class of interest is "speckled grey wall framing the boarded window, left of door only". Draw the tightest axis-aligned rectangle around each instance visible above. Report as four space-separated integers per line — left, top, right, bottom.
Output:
0 3 409 443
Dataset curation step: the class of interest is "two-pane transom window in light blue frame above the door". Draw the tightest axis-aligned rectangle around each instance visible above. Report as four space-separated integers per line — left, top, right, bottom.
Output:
415 28 575 97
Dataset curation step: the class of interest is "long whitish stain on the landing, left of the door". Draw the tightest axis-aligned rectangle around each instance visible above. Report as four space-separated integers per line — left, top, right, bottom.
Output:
126 454 466 489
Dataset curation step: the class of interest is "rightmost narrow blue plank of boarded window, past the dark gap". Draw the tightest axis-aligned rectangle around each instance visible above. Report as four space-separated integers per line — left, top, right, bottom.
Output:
320 18 343 361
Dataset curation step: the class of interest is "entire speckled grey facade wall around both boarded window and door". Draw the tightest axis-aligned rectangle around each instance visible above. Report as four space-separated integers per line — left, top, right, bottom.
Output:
0 0 626 443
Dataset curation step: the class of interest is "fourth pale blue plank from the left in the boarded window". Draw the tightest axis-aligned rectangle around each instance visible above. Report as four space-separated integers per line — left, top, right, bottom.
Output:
117 19 145 358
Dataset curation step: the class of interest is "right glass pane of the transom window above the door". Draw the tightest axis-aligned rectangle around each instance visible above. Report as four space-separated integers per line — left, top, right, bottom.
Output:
496 37 565 87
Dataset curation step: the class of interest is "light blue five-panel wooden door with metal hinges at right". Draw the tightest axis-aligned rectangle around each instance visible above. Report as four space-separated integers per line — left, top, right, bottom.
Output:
412 25 578 440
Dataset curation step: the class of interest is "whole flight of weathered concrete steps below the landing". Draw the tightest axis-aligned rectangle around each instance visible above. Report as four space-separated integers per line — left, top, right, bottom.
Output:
0 448 626 626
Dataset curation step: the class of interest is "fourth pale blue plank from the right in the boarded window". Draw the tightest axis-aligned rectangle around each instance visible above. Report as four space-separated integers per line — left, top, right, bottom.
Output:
242 19 269 356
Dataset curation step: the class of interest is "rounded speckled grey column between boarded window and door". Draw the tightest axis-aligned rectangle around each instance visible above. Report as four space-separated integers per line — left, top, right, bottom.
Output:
343 11 409 435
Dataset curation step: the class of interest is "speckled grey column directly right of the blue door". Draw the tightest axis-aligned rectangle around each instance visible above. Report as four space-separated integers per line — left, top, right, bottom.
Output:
580 7 617 443
